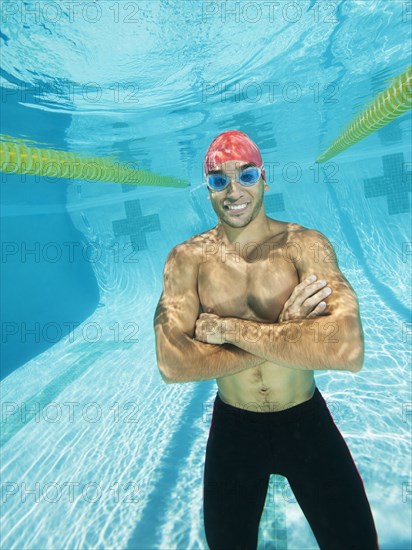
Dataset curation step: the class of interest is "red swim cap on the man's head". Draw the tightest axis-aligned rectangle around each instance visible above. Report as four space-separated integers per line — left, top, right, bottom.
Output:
203 130 266 181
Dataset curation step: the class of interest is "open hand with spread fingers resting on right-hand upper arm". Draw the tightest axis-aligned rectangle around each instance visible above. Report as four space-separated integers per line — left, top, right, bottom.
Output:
277 279 332 323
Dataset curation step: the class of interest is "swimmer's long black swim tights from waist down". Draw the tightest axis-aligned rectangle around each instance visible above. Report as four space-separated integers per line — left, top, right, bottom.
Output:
203 388 379 550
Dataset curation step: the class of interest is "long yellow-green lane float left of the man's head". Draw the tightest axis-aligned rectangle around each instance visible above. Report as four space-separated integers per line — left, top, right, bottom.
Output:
0 136 189 188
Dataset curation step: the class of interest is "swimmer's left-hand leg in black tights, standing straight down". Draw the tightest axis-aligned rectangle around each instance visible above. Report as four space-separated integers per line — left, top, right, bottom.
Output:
203 418 270 550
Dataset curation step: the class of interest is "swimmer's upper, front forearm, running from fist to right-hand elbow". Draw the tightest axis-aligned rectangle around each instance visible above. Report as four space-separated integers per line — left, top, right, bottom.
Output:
223 316 361 371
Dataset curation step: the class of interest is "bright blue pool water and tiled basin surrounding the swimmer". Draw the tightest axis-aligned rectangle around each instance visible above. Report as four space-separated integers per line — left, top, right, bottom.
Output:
0 0 412 550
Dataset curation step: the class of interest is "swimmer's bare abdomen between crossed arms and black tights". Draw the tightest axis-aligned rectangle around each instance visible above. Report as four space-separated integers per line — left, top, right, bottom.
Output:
216 361 315 412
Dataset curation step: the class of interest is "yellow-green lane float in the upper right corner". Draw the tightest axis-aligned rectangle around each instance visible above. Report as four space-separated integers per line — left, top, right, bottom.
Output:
316 66 412 163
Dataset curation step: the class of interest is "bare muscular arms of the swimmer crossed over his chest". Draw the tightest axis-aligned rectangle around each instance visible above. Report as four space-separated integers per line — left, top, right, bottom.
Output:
154 230 364 383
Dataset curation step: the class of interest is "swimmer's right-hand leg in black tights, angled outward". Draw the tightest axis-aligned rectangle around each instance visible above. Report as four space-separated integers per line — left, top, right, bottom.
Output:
286 409 379 550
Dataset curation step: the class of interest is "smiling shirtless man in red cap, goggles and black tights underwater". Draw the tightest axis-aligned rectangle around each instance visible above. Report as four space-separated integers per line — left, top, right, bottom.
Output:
154 130 379 550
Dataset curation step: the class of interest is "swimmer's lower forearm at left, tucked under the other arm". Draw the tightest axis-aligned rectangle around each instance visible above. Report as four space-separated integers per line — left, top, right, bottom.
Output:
159 335 265 383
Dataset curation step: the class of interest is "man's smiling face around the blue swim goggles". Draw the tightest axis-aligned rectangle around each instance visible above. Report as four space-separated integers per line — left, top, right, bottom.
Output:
209 160 264 228
